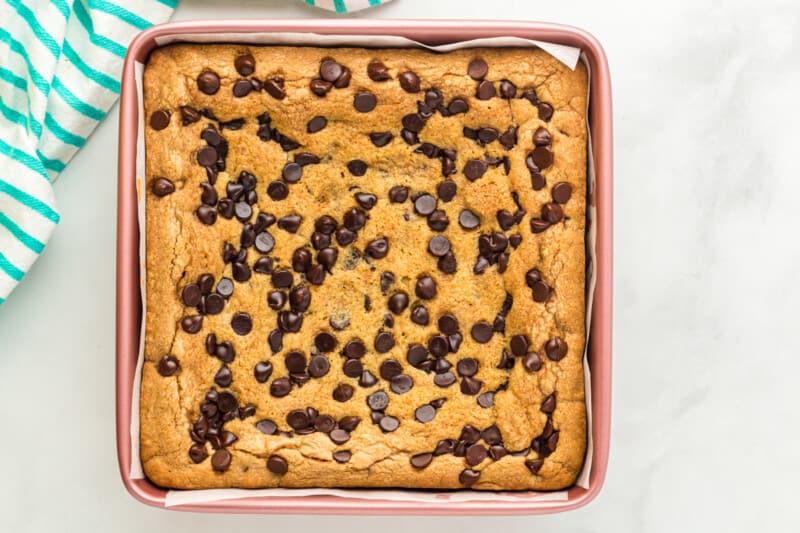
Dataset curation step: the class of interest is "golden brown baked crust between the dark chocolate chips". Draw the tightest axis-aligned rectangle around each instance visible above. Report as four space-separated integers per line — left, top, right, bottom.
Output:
141 45 587 490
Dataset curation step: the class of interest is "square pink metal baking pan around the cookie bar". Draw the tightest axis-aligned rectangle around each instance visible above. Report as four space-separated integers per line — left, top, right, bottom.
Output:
116 19 613 515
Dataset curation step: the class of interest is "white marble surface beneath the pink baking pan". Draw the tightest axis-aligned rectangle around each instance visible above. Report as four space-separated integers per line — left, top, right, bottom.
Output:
0 0 800 533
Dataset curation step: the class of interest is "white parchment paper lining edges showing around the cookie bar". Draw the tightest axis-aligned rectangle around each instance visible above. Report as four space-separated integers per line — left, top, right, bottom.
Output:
130 33 597 507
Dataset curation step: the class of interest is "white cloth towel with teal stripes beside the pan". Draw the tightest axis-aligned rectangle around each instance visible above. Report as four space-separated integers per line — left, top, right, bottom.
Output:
0 0 388 305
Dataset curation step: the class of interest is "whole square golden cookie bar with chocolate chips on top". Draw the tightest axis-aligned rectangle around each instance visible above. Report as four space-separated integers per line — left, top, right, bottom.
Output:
140 44 588 490
